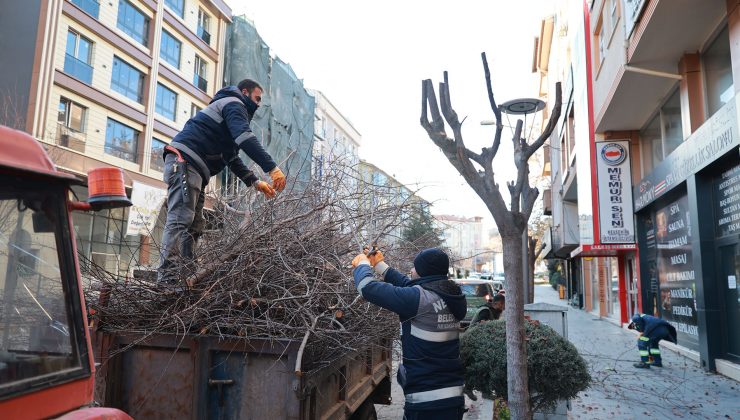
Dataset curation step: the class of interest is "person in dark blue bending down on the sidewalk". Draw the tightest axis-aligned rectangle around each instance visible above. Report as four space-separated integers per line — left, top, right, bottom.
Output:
628 314 677 369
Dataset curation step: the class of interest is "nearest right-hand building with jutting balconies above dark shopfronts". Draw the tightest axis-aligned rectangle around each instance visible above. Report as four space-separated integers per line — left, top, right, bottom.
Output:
589 0 740 375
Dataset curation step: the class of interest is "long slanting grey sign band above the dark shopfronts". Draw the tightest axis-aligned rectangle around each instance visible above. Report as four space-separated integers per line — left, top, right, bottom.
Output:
633 96 740 211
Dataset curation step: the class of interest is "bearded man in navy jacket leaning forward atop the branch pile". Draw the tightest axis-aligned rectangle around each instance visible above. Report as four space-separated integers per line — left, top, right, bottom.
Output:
157 79 285 284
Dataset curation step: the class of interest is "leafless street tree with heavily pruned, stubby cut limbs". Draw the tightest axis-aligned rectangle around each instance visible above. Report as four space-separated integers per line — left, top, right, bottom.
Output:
421 53 562 419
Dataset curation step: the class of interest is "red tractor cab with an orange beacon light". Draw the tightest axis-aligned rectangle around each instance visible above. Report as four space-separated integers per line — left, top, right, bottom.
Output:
0 126 131 419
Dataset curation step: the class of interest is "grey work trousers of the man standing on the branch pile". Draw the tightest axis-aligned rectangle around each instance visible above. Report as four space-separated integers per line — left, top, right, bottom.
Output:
157 153 207 284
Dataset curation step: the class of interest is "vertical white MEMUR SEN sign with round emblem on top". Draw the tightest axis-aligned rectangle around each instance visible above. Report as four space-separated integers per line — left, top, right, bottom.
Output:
596 140 635 244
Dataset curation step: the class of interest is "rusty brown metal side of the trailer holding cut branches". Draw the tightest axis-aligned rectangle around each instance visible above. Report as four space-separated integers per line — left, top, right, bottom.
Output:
94 331 391 420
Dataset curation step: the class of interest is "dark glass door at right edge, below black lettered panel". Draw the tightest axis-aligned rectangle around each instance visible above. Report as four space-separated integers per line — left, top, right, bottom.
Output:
718 243 740 362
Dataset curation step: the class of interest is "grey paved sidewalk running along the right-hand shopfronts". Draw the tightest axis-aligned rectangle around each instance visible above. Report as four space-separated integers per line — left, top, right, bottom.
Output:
535 286 740 420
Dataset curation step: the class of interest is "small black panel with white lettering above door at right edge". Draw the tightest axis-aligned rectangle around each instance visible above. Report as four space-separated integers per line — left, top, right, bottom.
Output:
714 165 740 237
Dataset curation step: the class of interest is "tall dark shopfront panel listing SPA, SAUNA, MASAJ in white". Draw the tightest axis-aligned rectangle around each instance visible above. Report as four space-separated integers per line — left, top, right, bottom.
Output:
641 196 699 349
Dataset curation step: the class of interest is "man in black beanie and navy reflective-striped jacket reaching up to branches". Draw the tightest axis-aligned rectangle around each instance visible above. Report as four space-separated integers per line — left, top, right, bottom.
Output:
352 248 467 420
